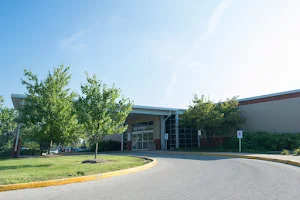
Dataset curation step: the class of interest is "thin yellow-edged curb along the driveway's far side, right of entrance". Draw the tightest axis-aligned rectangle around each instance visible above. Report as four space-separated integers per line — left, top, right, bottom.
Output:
152 151 300 167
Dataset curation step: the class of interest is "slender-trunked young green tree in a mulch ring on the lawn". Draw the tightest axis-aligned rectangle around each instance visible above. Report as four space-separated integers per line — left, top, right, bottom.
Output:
77 74 132 159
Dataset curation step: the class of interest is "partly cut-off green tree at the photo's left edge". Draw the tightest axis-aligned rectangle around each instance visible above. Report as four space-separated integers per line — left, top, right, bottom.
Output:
0 96 17 148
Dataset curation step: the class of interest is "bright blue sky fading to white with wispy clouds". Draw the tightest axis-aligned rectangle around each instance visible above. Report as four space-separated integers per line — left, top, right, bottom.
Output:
0 0 300 108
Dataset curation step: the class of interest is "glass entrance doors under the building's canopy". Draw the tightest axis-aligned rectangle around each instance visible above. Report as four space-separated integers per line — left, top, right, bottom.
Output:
132 130 153 150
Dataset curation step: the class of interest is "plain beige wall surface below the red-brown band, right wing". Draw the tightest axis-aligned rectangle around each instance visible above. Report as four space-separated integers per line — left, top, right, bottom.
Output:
240 97 300 133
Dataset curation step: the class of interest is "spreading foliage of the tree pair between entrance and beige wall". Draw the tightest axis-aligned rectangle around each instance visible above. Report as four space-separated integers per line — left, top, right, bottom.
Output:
182 95 246 145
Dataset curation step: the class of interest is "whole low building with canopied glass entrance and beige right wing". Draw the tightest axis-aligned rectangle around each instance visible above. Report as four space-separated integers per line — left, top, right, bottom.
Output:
11 90 300 150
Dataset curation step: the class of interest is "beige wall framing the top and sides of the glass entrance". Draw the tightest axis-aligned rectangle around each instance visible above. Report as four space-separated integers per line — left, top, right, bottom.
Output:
127 114 160 139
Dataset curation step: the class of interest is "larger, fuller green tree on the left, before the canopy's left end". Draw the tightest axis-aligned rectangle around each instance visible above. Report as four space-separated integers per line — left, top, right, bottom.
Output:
20 65 80 152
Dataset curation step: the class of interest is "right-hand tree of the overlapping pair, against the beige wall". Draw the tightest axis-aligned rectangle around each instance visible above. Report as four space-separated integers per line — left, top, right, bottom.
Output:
215 97 246 147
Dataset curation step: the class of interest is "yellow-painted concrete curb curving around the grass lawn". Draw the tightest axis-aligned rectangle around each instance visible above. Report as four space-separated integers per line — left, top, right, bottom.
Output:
0 156 157 192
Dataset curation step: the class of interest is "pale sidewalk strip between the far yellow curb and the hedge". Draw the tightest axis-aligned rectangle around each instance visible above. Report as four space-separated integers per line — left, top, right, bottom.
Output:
143 151 300 167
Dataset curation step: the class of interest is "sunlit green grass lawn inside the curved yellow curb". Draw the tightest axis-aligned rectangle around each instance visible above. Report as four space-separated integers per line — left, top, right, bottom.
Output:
0 155 144 185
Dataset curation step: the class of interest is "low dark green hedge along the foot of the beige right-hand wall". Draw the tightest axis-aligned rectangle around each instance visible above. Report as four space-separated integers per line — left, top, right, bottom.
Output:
224 132 300 151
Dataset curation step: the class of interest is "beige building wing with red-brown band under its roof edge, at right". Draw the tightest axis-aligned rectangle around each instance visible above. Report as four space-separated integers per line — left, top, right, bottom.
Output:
239 90 300 133
